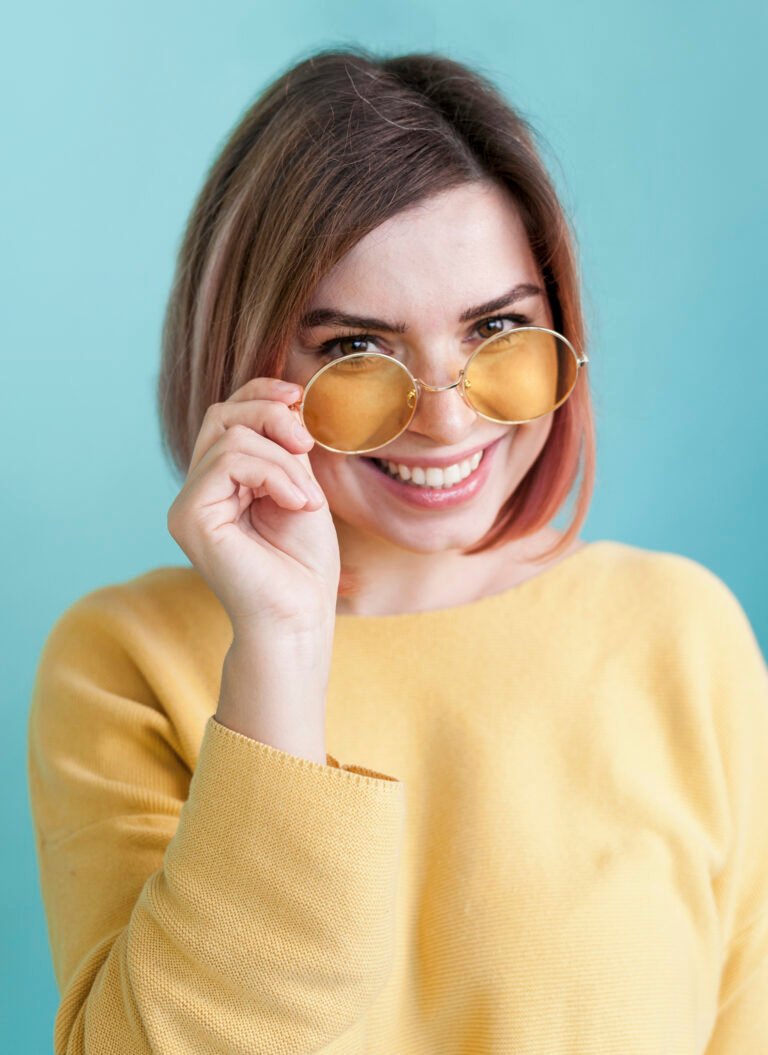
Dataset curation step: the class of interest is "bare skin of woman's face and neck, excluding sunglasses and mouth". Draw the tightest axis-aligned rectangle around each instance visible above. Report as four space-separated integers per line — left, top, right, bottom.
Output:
284 183 584 615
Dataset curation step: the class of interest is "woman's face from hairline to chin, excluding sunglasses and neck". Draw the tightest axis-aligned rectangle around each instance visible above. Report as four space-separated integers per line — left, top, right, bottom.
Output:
284 183 554 553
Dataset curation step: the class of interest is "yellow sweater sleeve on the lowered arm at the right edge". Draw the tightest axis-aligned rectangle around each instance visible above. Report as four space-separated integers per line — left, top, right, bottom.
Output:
700 575 768 1055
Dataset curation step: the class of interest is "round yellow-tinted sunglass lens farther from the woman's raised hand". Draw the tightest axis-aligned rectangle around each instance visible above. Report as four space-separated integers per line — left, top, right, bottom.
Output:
464 329 578 422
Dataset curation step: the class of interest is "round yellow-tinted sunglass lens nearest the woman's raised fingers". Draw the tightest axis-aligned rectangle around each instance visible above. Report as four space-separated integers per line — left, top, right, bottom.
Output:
302 353 416 452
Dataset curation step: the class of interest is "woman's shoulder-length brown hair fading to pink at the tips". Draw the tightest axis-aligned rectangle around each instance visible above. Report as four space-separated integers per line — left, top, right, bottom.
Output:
157 46 595 593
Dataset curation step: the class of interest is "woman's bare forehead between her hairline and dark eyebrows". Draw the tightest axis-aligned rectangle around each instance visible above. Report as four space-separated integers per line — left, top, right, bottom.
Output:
311 184 540 312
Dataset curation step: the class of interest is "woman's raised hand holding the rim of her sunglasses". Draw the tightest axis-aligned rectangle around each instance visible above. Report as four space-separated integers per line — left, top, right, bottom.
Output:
168 378 340 638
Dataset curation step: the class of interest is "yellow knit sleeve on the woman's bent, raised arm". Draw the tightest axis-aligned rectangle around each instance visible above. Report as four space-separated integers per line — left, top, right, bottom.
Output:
27 591 405 1055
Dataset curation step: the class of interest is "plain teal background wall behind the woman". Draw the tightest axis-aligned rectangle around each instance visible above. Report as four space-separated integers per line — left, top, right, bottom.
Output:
6 0 768 1052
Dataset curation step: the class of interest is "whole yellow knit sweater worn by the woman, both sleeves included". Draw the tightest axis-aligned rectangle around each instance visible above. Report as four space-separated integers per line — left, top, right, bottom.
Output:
28 540 768 1055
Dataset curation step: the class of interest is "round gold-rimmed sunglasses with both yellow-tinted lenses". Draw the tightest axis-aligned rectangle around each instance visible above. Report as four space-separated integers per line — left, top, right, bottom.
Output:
286 326 589 455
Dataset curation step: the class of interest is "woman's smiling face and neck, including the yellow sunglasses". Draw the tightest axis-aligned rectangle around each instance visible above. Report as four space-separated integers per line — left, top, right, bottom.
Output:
283 178 594 615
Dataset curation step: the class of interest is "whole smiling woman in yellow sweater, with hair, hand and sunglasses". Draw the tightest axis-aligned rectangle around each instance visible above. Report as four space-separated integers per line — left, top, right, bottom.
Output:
30 50 768 1055
